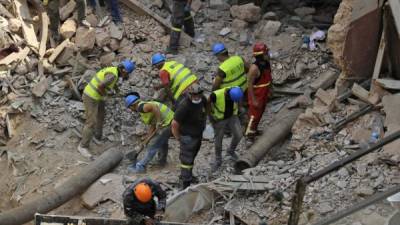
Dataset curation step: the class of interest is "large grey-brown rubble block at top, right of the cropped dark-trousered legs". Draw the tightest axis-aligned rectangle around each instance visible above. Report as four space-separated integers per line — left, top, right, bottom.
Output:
230 3 261 23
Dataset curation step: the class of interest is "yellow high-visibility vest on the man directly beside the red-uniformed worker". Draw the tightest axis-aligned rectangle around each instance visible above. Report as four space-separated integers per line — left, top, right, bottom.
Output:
219 56 247 92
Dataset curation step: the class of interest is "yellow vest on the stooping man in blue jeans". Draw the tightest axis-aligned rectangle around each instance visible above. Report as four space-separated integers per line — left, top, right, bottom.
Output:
139 101 174 127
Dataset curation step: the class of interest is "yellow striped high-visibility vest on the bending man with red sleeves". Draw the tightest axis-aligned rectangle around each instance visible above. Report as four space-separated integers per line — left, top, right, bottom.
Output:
161 61 197 100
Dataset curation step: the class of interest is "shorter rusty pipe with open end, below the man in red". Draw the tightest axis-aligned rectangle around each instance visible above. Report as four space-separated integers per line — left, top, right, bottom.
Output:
234 108 304 173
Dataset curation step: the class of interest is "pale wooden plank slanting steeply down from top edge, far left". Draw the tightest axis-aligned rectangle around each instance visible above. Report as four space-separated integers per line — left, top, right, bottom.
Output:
13 0 39 49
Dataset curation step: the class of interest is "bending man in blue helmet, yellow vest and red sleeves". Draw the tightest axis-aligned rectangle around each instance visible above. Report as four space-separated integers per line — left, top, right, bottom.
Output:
151 53 197 108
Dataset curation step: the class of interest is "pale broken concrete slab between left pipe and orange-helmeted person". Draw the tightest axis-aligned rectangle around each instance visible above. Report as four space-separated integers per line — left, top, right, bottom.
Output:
81 173 125 209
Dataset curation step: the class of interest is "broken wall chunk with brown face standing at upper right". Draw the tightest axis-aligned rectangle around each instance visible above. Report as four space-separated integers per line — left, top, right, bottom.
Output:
328 0 382 93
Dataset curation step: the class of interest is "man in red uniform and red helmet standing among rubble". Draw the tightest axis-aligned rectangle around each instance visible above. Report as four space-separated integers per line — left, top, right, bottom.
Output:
246 42 272 136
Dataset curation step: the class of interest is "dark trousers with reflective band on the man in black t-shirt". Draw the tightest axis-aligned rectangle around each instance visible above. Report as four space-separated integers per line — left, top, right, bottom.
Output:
179 136 203 188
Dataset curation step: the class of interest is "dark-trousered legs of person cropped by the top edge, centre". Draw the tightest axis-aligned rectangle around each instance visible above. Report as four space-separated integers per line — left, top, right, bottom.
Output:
167 0 194 55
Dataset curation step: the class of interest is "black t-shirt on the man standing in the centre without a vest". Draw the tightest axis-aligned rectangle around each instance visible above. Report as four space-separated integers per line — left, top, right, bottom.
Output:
174 96 207 137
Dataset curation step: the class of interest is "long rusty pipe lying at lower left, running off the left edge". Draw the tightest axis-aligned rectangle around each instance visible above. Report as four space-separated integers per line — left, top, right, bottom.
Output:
0 149 123 225
